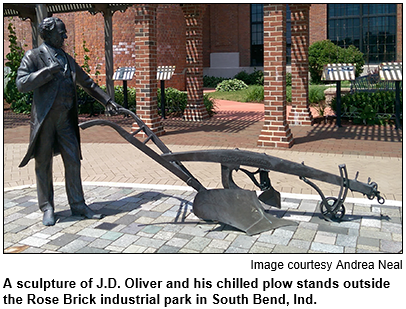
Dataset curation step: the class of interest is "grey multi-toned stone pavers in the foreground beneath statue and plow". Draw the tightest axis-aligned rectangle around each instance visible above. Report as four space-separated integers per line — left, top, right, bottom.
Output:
4 185 402 253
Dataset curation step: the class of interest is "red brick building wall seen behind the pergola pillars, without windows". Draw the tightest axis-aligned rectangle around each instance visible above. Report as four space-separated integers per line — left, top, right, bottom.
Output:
4 4 403 90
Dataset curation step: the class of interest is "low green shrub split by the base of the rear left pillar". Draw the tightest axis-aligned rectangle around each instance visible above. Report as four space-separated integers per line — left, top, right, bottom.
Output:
157 87 215 116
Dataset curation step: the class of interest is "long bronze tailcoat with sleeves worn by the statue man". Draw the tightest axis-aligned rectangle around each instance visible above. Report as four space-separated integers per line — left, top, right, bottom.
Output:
16 43 110 167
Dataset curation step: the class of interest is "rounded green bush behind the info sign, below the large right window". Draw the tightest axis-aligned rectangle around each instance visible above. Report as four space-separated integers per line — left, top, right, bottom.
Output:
309 40 365 84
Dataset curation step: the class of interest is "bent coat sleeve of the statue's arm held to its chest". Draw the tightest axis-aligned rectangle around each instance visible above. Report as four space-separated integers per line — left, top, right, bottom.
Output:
16 50 53 92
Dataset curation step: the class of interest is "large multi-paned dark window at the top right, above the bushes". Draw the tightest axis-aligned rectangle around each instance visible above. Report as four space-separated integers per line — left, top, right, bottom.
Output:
328 4 396 63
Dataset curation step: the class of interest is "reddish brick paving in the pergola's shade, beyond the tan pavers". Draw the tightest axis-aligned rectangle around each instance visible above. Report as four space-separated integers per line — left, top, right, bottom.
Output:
4 100 403 158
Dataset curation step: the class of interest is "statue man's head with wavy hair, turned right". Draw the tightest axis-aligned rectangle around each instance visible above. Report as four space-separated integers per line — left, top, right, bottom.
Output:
38 17 68 48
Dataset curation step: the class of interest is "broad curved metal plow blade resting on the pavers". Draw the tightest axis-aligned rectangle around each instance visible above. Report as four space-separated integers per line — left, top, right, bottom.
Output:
193 189 297 235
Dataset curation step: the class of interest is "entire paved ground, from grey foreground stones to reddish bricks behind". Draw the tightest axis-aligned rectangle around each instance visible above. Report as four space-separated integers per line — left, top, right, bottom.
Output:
3 104 403 253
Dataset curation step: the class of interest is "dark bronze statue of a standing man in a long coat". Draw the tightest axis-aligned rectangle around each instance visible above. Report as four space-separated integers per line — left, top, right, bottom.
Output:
16 17 120 226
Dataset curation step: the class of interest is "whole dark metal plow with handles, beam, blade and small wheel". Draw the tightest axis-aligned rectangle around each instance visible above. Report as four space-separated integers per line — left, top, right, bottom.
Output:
80 108 385 235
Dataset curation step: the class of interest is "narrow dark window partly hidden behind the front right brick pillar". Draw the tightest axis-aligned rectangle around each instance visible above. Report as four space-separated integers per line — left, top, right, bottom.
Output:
251 4 292 66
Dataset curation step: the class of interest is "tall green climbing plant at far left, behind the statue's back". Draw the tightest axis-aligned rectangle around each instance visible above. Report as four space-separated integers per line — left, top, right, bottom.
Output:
4 18 32 114
